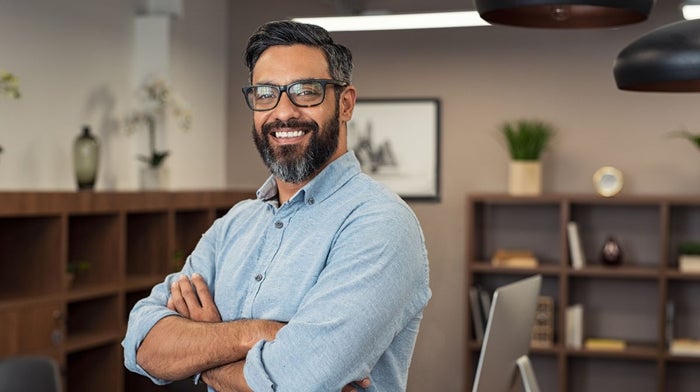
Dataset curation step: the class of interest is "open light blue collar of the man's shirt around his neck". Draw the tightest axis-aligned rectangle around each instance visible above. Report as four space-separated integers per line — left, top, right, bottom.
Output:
256 151 361 204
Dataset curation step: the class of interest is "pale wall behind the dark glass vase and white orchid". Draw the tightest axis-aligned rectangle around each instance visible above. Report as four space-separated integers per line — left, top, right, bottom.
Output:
0 0 228 190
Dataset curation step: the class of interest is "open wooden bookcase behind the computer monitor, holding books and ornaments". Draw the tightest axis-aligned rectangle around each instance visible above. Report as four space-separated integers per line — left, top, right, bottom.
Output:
466 194 700 392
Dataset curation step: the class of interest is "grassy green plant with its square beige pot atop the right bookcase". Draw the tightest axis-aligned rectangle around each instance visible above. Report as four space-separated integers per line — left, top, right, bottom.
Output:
501 120 554 195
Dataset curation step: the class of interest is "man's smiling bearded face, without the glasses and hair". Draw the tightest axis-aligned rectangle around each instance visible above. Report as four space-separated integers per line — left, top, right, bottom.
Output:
252 45 347 184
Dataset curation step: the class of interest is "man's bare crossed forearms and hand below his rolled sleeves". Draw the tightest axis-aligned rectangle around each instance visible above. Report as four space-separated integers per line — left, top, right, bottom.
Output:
137 274 370 392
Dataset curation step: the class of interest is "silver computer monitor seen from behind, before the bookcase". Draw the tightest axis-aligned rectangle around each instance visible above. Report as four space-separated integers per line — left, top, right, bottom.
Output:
472 275 542 392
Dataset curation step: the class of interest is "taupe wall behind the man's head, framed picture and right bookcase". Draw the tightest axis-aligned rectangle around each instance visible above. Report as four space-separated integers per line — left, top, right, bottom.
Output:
227 1 700 391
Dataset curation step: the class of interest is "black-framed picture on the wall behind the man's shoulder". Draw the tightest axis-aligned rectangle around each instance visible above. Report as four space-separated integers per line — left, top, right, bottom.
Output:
348 98 440 201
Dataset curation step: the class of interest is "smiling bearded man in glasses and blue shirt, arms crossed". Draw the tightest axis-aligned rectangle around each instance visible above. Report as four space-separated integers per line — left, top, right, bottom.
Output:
122 21 430 392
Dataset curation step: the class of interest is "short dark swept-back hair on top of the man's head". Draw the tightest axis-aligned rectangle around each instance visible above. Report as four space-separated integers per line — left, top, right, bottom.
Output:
244 20 352 84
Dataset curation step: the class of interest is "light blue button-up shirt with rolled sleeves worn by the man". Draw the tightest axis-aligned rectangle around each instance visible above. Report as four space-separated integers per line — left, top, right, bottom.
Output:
122 152 431 392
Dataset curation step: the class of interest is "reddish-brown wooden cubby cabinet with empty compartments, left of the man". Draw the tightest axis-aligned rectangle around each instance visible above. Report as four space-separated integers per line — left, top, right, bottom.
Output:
0 191 254 392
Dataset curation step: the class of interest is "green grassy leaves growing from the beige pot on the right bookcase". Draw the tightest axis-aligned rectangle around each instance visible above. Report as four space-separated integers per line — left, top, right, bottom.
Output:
501 120 554 161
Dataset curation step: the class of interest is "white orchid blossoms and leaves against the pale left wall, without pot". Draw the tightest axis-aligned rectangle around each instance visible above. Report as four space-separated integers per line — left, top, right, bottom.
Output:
125 78 192 168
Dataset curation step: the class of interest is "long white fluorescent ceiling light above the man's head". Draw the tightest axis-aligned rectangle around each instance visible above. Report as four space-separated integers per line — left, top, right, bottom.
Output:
293 11 489 31
